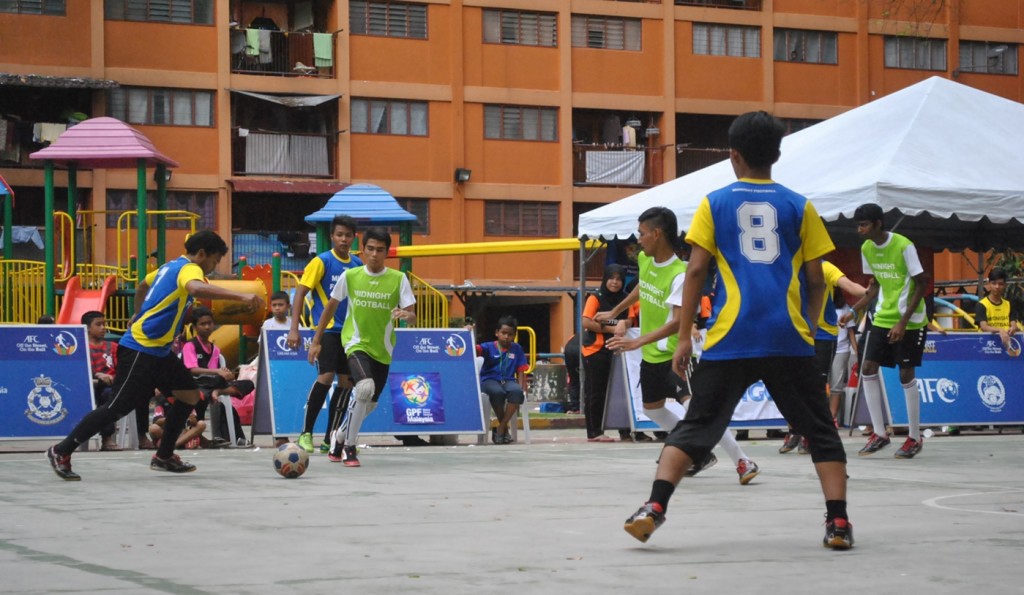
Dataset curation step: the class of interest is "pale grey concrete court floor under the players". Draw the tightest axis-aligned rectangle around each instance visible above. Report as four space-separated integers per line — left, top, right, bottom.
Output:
0 428 1024 595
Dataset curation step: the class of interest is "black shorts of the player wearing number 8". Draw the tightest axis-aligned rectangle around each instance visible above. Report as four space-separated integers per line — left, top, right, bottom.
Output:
666 356 846 463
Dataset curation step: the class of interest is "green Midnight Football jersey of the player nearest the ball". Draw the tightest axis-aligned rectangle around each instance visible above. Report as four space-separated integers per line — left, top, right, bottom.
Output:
331 266 416 364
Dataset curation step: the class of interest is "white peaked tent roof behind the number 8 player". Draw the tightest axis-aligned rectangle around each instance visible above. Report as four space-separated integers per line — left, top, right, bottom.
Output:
580 77 1024 249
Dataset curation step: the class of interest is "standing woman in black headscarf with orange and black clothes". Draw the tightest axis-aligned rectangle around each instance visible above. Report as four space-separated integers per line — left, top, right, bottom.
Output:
581 264 629 442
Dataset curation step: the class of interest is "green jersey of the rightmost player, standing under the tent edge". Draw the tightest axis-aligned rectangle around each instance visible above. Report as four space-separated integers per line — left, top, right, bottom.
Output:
860 232 928 331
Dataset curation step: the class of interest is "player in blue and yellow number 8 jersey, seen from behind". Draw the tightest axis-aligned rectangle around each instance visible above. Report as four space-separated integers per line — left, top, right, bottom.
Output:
625 112 853 549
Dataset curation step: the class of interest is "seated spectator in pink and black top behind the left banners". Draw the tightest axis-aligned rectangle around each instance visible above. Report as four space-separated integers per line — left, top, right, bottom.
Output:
181 306 255 445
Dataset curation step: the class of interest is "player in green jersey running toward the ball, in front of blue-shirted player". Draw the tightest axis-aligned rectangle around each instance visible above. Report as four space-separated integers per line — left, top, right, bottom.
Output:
309 227 416 467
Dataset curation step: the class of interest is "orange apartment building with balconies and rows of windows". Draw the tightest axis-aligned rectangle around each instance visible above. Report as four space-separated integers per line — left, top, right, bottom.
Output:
0 0 1024 351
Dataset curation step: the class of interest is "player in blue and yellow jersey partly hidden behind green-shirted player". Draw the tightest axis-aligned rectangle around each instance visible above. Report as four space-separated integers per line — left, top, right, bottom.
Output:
288 215 362 453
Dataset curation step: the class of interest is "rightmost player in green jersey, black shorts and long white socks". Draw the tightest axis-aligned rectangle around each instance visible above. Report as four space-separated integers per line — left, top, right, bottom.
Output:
853 203 928 459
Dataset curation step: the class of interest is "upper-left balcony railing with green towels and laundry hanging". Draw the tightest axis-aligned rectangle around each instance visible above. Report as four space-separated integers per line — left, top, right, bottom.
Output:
230 29 335 79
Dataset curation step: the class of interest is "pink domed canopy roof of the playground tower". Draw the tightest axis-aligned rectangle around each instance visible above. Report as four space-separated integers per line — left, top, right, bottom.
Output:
29 117 178 169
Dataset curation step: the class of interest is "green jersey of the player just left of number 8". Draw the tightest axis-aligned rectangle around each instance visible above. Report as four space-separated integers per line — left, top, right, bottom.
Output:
637 253 686 364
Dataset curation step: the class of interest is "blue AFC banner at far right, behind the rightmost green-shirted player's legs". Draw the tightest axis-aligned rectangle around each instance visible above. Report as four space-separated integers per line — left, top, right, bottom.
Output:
882 333 1024 426
